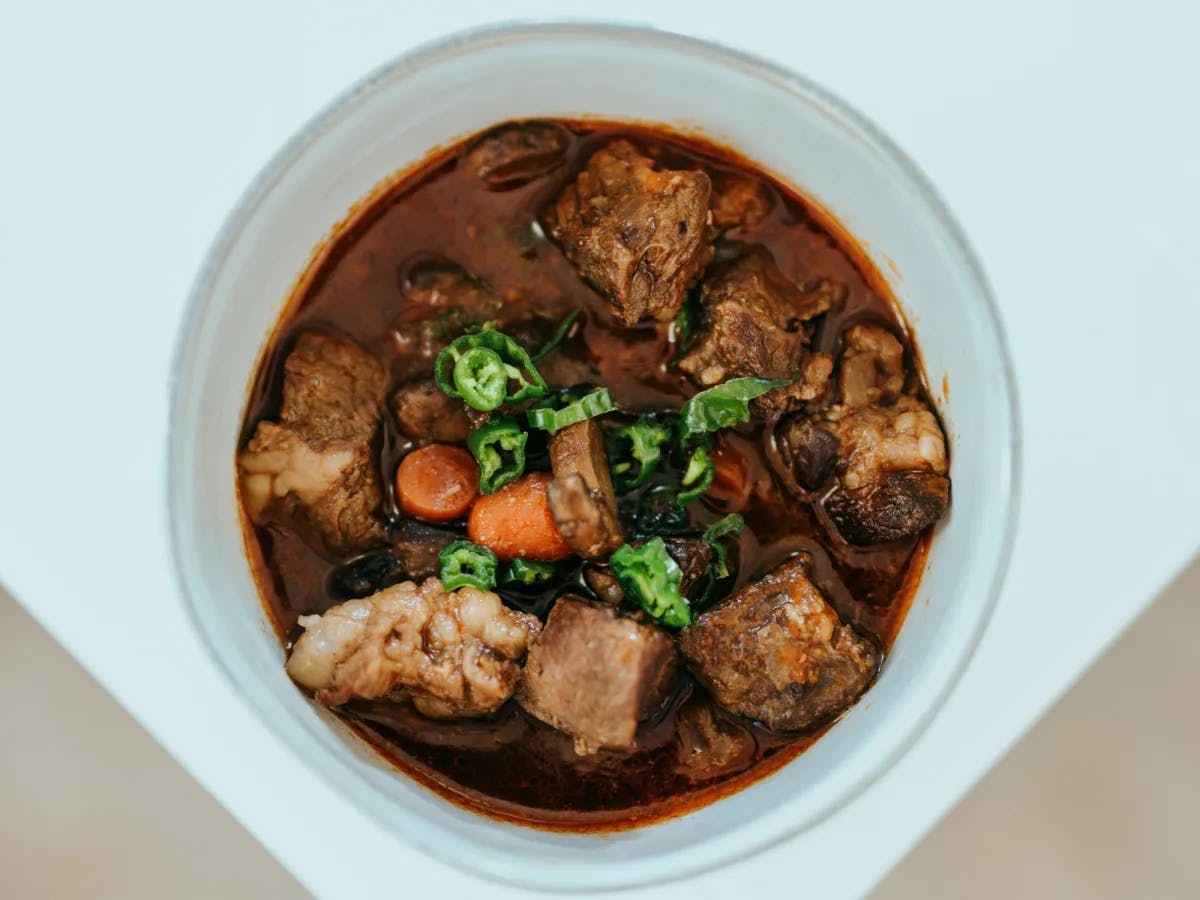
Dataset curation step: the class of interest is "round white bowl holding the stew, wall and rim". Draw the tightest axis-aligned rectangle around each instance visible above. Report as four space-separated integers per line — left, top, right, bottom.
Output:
168 24 1018 889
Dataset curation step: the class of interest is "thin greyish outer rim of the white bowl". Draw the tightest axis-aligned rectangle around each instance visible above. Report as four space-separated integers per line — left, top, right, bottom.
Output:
163 17 1022 892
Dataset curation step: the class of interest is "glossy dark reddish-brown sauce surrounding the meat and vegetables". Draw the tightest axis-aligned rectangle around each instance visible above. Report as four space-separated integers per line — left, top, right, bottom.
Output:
242 124 929 829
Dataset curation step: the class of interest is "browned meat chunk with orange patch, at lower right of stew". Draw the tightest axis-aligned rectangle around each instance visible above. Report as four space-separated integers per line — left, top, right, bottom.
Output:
679 557 878 731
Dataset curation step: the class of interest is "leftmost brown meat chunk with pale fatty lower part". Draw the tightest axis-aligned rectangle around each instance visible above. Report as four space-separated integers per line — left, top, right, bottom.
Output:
238 332 386 553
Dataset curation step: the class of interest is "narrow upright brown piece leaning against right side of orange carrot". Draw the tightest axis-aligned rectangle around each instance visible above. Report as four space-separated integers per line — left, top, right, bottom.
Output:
546 419 624 559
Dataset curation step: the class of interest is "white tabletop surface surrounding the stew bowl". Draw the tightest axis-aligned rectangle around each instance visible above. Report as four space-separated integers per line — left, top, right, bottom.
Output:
0 0 1200 898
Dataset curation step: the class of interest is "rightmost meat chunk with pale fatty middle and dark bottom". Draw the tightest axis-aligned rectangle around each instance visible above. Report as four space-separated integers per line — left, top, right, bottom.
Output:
817 324 950 544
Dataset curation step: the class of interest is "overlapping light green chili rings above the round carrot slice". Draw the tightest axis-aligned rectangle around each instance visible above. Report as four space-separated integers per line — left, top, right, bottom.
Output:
433 328 547 412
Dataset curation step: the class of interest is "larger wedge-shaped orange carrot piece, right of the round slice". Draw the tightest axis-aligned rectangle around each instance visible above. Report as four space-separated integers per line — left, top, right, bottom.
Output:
467 472 571 563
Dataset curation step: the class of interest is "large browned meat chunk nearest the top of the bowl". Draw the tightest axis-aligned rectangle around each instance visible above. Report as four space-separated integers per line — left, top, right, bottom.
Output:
545 140 714 325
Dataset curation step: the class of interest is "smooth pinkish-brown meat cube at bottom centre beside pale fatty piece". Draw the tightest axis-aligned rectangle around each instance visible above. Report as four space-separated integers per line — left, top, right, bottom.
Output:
517 596 677 756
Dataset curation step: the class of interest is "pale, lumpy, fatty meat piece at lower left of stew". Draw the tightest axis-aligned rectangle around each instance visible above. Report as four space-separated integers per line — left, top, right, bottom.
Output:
287 578 540 718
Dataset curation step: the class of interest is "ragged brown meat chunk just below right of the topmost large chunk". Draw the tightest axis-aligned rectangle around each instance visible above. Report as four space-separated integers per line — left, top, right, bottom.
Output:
679 251 844 415
